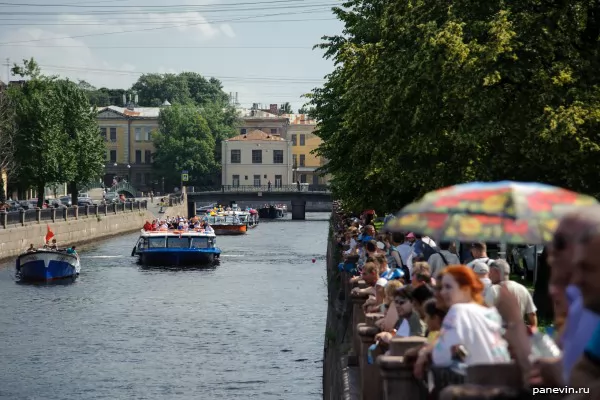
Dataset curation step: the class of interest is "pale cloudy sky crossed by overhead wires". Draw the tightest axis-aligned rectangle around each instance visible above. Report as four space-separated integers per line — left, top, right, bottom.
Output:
0 0 343 112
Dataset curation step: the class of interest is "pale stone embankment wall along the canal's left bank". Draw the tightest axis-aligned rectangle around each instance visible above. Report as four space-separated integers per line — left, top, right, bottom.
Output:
0 208 154 260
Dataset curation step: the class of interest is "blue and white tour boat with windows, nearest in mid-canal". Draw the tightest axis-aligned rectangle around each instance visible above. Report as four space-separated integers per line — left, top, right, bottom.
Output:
131 229 221 266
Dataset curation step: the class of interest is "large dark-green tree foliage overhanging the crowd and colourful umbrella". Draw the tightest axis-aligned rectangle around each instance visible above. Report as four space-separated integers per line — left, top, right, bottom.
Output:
310 0 600 211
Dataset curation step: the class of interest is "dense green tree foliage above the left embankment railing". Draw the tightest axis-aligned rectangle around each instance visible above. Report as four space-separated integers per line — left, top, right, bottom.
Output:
8 59 105 206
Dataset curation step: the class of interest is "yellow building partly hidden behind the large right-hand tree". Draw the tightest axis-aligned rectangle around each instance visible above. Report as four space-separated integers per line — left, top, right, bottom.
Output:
283 114 327 185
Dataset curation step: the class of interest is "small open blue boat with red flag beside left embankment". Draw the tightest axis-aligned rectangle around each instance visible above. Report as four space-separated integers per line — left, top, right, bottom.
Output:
16 249 81 282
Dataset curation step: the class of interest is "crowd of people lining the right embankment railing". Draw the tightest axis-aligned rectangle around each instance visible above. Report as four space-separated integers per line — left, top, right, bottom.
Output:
334 206 600 398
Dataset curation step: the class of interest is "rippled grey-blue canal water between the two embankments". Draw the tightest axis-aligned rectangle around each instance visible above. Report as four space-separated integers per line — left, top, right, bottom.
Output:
0 213 328 400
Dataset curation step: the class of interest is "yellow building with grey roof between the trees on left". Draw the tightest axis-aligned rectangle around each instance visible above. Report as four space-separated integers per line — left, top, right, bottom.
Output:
98 106 162 192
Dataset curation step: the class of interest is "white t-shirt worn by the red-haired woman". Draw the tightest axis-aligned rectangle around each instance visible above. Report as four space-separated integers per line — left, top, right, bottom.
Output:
432 303 510 366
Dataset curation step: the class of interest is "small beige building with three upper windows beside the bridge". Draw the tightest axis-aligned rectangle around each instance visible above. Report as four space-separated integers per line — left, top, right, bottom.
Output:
221 129 293 187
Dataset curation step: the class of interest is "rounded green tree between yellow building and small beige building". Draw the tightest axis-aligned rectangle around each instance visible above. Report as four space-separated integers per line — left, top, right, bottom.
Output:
153 105 217 187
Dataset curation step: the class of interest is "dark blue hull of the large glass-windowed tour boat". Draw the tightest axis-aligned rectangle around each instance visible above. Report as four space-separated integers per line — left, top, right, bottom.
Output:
137 248 221 266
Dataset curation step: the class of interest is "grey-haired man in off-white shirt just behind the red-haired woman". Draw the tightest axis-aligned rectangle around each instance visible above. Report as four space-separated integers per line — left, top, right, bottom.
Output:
485 259 537 327
